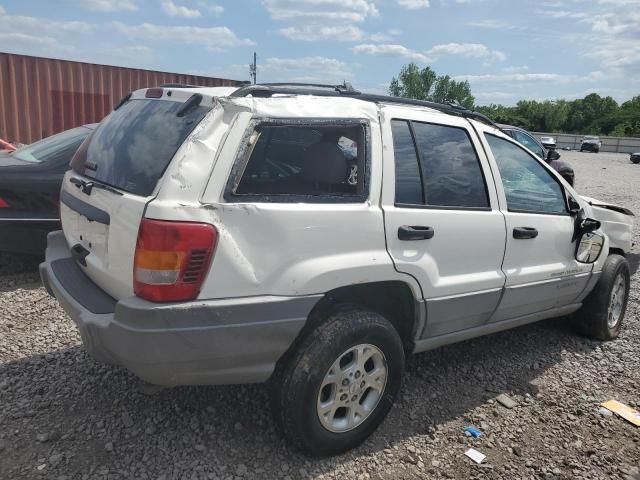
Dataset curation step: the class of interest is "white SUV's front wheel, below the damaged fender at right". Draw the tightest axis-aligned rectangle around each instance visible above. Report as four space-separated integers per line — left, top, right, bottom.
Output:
574 255 630 341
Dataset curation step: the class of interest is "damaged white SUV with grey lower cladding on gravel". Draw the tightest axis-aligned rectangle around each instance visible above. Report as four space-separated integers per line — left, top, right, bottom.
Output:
40 84 629 455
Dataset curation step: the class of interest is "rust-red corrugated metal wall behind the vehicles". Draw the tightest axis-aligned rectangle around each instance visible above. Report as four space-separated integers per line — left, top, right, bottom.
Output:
0 52 238 143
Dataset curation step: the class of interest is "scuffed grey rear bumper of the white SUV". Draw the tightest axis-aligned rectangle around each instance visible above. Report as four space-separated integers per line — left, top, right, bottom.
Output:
40 232 320 385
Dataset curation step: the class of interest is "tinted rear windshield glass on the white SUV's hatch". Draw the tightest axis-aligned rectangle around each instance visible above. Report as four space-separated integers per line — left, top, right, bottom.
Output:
79 100 211 196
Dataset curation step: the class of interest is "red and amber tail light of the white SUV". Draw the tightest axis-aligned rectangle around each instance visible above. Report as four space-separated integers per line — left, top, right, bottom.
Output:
133 218 218 302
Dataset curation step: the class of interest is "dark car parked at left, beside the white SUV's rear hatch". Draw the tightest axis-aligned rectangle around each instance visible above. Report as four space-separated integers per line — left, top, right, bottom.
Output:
0 124 96 254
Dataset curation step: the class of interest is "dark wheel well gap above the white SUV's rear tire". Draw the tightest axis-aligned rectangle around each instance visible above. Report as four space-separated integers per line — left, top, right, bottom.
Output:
303 281 420 352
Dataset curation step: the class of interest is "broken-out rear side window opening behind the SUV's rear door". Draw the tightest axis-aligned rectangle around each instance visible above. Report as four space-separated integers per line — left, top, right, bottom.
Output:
231 121 367 202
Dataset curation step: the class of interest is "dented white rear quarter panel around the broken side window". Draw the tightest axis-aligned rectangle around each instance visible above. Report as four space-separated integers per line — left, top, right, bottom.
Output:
170 97 422 299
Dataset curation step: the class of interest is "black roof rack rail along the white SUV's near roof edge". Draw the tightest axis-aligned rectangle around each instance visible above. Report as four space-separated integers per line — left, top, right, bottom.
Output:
231 82 496 127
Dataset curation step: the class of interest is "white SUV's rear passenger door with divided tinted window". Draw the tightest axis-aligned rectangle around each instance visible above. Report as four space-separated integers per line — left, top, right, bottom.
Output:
382 107 506 337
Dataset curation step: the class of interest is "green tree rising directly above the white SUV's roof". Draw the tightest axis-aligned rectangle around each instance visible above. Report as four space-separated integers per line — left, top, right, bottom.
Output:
389 62 475 108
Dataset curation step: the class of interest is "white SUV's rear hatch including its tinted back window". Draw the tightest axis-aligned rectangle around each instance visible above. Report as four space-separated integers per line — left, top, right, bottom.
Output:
60 88 212 299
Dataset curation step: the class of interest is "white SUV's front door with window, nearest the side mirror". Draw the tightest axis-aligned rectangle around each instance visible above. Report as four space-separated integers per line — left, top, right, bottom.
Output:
478 126 592 322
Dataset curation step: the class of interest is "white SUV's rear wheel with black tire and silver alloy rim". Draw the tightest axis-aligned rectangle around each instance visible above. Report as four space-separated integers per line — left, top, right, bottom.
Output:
271 306 405 456
